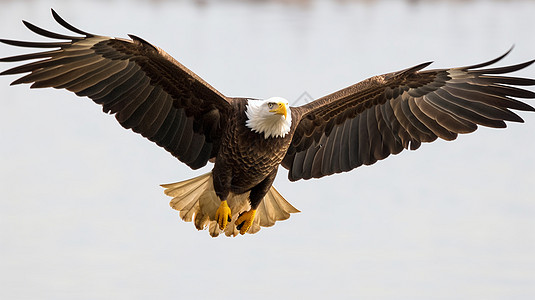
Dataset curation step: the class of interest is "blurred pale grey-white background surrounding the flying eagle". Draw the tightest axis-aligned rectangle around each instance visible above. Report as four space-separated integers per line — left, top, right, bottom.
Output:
0 0 535 299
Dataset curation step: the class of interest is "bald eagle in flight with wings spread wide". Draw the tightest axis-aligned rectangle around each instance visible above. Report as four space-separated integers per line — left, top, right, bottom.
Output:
0 10 535 236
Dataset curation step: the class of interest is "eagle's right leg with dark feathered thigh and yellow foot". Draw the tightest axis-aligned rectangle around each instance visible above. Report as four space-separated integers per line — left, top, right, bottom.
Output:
235 168 277 234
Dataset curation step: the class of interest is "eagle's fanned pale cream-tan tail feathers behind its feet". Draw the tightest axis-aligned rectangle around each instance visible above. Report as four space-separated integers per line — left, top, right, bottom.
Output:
161 172 300 237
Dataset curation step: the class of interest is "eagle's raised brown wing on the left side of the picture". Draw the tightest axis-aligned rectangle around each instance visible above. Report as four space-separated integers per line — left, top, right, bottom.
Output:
0 10 231 169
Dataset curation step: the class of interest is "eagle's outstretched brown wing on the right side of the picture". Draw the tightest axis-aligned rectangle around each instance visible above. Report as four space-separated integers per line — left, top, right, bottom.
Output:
282 50 535 181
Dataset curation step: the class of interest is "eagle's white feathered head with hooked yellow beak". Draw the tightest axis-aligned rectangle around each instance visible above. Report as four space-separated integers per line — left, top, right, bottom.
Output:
245 97 292 139
